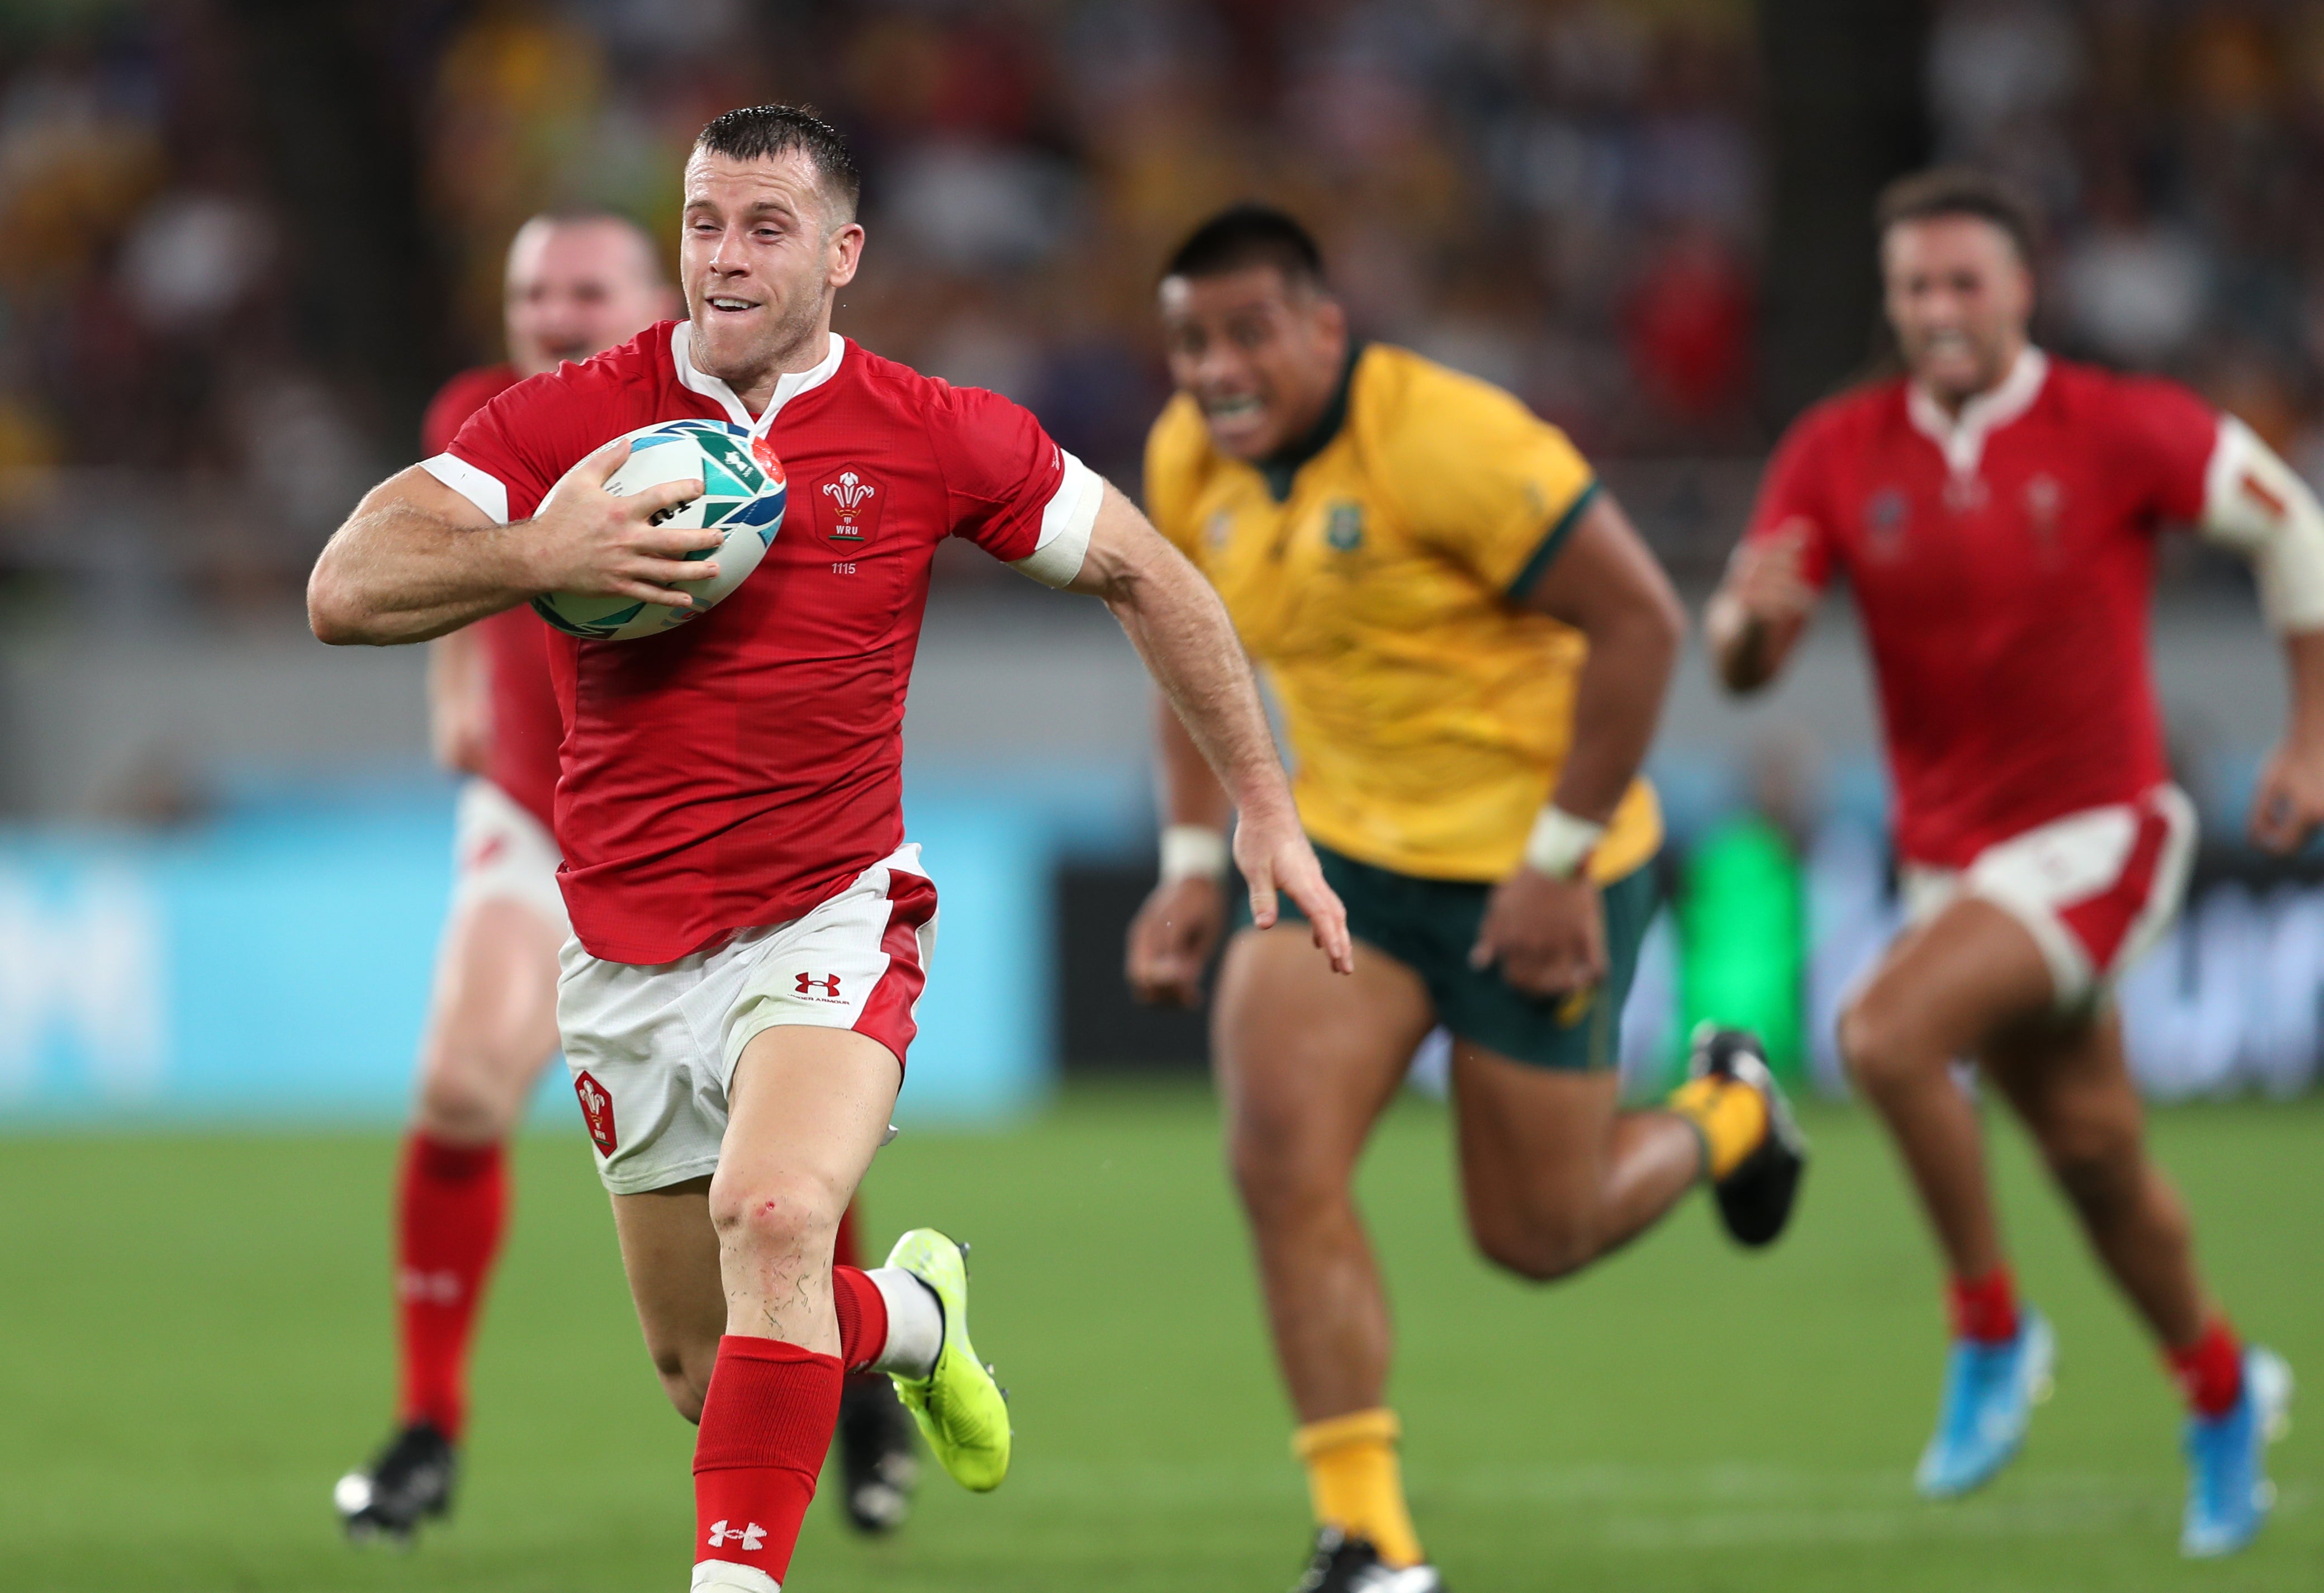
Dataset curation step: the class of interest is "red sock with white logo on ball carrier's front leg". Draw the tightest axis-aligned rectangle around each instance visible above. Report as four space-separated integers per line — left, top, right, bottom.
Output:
695 1333 846 1581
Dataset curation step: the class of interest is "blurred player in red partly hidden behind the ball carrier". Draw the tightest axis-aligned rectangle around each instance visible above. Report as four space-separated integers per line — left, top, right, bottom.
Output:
335 212 916 1537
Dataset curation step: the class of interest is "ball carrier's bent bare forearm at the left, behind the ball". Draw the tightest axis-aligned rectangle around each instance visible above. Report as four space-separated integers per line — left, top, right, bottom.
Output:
307 500 532 647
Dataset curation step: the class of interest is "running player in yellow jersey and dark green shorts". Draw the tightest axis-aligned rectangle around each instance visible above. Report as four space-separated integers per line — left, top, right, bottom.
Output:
1130 207 1806 1593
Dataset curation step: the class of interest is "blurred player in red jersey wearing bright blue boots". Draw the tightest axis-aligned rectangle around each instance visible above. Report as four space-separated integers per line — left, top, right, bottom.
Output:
1706 170 2324 1556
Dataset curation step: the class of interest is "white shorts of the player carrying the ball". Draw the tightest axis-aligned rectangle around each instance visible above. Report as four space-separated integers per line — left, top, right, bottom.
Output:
558 844 937 1196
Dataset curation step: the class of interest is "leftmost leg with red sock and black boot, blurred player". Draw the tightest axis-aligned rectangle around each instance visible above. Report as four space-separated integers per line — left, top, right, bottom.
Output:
335 898 565 1537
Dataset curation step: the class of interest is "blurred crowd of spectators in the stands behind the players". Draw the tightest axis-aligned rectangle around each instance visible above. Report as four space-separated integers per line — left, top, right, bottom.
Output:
13 0 2324 603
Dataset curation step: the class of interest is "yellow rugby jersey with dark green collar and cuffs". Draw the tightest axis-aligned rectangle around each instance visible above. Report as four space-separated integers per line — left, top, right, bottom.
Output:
1146 344 1662 881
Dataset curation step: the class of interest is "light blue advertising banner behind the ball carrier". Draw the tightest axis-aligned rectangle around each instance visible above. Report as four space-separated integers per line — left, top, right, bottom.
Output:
0 788 1055 1123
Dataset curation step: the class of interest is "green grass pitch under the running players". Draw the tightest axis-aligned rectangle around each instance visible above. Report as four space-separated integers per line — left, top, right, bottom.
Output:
0 1088 2324 1593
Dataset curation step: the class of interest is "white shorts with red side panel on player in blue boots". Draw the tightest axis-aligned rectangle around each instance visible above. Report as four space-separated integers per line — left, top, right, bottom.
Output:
1899 786 2196 1009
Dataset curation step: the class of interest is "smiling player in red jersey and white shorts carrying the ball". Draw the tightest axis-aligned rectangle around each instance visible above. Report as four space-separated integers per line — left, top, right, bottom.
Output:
309 107 1353 1593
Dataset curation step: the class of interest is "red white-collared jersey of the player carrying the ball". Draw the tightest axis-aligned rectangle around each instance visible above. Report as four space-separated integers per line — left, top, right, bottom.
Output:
428 321 1097 963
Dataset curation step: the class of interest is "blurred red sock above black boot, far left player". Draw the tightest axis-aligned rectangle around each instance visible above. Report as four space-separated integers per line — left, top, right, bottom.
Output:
395 1132 509 1439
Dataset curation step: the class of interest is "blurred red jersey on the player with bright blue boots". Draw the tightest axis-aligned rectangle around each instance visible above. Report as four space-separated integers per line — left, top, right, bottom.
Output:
1746 349 2219 867
